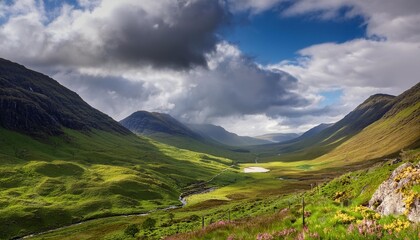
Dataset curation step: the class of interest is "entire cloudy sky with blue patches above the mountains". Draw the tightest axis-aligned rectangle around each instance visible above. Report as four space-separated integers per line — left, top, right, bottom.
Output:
0 0 420 135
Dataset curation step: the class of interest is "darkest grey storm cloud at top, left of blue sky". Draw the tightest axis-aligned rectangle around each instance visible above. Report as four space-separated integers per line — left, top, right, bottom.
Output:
102 0 228 68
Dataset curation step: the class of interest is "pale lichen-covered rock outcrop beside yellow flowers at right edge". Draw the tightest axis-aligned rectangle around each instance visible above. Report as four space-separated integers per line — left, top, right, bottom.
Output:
369 163 420 223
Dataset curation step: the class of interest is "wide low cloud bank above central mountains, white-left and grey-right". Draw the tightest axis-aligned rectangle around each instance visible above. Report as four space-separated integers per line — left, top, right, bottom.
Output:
48 42 319 123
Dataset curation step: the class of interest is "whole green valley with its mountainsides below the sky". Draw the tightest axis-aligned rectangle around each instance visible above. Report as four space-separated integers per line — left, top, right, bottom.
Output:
0 57 420 239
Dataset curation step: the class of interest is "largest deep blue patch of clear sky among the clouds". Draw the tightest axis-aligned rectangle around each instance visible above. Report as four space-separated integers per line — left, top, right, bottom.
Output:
222 9 366 64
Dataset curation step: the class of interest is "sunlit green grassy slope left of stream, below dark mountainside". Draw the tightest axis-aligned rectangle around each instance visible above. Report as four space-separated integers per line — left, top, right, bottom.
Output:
0 129 232 239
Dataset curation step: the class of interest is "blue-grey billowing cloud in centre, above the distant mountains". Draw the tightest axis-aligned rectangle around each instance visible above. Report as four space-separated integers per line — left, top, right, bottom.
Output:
172 47 310 121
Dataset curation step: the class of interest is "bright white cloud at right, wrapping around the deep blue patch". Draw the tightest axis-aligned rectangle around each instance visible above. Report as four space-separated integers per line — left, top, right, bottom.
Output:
270 0 420 113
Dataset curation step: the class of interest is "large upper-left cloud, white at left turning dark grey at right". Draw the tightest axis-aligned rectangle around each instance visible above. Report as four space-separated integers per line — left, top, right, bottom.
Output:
0 0 229 69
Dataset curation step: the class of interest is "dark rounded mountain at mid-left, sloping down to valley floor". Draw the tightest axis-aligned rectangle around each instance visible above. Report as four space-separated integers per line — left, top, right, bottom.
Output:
120 111 254 161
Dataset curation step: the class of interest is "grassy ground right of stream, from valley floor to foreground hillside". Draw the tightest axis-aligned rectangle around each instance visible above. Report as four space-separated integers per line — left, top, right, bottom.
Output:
20 150 419 239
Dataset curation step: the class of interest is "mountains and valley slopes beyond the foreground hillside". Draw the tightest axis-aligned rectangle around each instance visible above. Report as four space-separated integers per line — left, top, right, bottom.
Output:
0 59 420 239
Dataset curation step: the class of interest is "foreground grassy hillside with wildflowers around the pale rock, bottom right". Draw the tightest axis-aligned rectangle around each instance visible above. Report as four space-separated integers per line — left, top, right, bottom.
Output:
167 157 420 240
